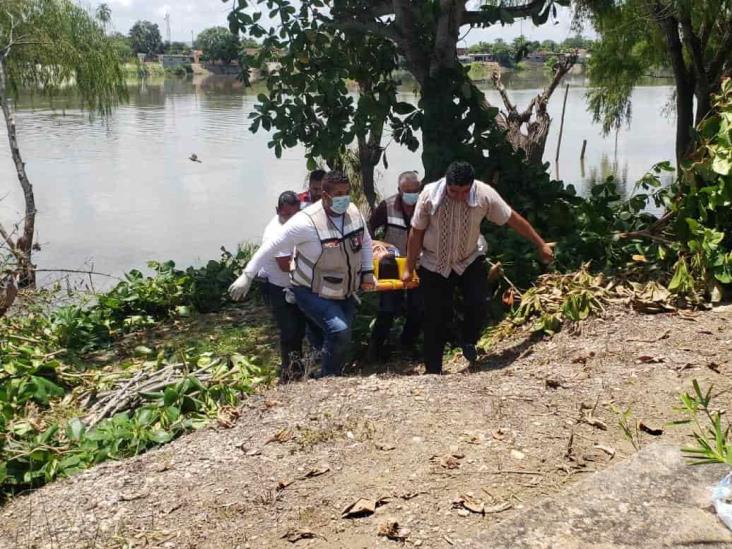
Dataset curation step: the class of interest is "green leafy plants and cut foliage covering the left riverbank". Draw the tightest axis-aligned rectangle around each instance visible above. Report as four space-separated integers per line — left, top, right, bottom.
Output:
0 248 273 497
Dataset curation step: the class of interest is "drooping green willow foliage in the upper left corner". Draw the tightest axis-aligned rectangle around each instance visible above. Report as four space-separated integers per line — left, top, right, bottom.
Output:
0 0 127 114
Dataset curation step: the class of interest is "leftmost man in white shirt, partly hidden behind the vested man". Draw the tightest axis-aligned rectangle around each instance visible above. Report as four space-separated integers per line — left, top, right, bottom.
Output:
258 191 307 383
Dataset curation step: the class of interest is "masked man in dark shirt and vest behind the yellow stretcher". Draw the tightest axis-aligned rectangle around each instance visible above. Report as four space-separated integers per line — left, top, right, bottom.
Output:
368 171 423 360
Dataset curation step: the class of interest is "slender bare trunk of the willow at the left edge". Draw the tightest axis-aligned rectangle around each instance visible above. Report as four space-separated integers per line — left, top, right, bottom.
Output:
0 56 36 287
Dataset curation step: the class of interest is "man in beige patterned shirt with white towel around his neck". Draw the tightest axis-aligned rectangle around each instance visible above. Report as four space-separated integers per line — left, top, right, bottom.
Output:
403 158 554 374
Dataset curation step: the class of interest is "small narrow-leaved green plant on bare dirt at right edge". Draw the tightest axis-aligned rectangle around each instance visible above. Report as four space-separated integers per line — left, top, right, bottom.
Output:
675 380 732 465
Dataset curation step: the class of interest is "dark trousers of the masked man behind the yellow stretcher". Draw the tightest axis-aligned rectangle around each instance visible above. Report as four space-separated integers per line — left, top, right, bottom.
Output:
371 288 424 348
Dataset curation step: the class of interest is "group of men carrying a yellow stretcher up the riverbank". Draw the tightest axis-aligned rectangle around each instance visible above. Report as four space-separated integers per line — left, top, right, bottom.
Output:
229 162 553 380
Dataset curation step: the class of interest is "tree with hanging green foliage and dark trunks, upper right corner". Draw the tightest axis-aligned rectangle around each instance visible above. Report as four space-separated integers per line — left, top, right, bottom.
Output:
580 0 732 165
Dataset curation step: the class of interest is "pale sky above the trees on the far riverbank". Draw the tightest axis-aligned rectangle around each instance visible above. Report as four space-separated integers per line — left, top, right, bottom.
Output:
87 0 588 45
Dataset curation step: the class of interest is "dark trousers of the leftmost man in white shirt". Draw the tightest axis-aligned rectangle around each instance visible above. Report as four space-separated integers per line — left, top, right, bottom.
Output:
266 282 306 380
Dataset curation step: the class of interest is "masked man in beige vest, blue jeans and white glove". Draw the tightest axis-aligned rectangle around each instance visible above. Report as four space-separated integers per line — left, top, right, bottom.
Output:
229 171 374 376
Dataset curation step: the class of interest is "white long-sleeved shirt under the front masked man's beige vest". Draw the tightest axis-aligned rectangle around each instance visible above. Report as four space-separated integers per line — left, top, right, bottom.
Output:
244 211 374 284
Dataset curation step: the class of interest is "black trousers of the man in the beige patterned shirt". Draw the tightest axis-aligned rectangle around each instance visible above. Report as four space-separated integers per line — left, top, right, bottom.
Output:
419 256 488 374
